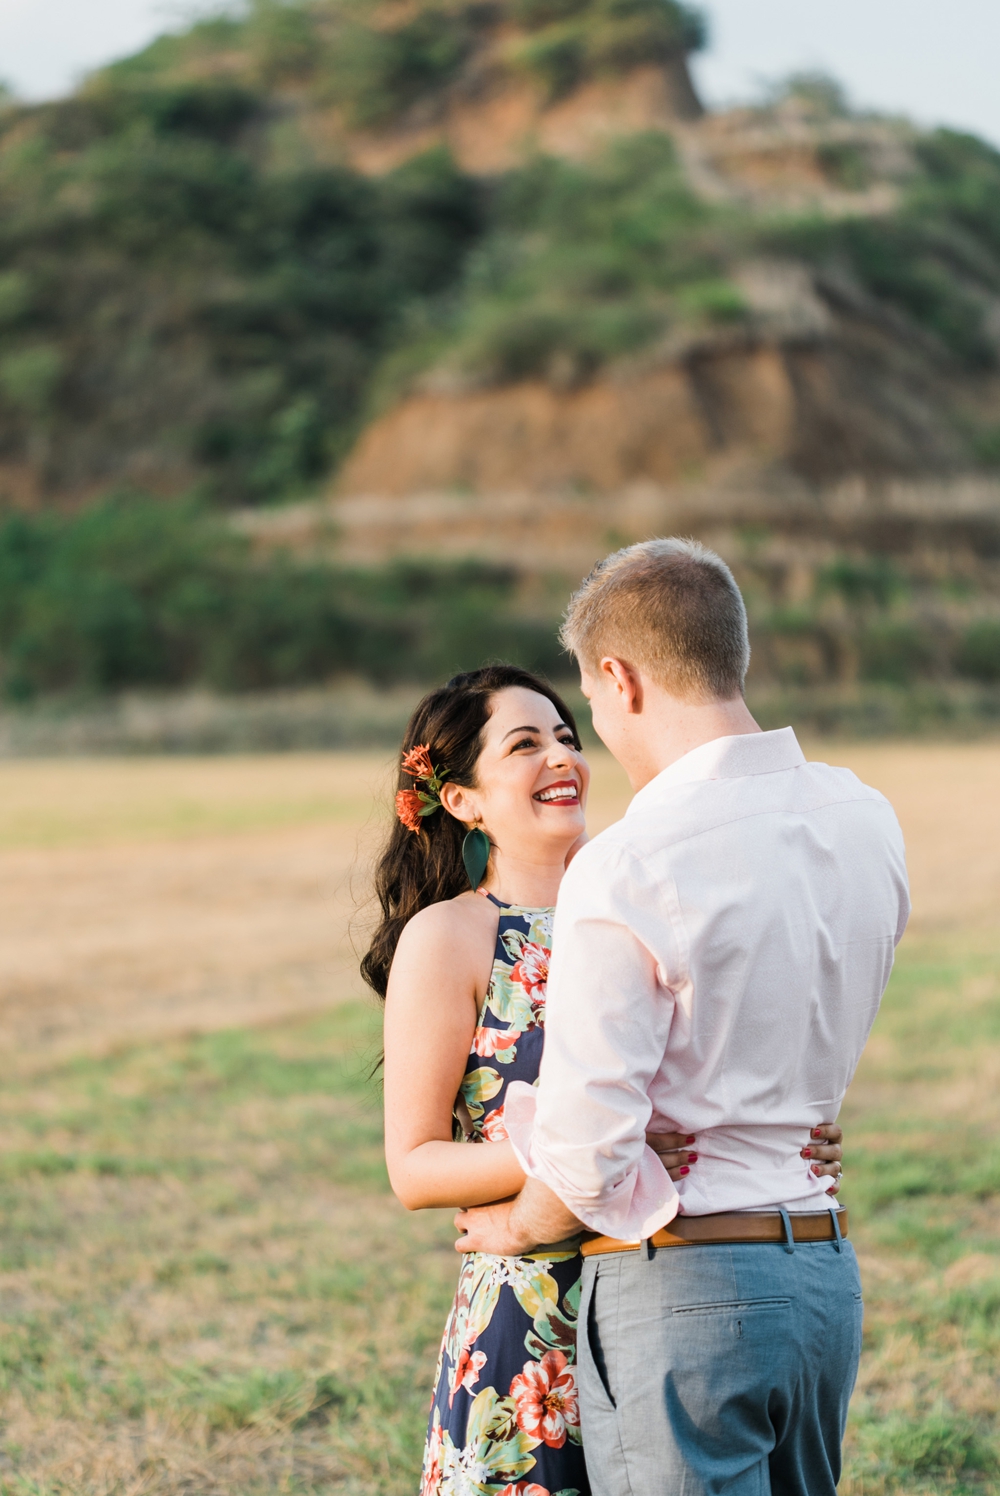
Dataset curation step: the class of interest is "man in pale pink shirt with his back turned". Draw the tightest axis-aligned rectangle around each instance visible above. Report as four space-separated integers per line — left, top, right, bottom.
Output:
457 540 909 1496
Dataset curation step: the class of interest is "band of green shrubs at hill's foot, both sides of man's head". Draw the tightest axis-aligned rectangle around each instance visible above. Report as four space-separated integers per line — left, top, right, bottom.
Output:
0 492 1000 702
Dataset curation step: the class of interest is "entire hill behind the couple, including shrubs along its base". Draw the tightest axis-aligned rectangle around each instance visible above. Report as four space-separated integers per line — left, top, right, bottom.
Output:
0 0 1000 726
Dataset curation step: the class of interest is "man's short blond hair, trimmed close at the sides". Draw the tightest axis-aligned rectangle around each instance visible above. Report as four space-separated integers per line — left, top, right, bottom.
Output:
560 539 750 702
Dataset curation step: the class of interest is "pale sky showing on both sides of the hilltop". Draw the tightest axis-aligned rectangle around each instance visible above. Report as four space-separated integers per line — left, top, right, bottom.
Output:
0 0 1000 145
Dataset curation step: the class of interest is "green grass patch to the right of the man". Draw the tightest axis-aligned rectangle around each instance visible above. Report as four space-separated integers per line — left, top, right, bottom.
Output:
841 934 1000 1496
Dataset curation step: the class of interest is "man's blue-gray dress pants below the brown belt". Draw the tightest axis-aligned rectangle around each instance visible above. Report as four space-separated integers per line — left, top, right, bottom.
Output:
578 1242 862 1496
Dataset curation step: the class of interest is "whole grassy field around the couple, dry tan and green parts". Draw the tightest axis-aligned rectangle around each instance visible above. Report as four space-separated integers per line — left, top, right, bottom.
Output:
0 745 1000 1496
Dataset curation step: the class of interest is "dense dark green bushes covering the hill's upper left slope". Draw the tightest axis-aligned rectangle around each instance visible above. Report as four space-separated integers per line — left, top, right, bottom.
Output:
0 76 482 501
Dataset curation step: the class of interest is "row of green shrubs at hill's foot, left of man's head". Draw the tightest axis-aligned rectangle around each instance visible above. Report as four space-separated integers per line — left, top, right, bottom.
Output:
0 494 561 700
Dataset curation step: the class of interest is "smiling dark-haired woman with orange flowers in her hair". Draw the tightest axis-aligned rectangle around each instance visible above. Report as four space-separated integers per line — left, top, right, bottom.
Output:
362 664 840 1496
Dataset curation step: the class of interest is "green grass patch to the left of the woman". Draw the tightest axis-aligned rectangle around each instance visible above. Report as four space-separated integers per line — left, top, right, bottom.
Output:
0 1004 457 1496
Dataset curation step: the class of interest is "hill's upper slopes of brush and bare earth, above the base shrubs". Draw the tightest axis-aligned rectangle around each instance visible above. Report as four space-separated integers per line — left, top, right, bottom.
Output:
0 0 1000 504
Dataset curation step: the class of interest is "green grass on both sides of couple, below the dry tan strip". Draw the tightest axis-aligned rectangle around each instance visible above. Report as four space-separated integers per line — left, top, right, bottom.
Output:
0 935 1000 1496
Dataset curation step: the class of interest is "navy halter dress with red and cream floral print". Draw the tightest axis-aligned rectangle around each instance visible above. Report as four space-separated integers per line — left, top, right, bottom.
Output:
421 895 590 1496
